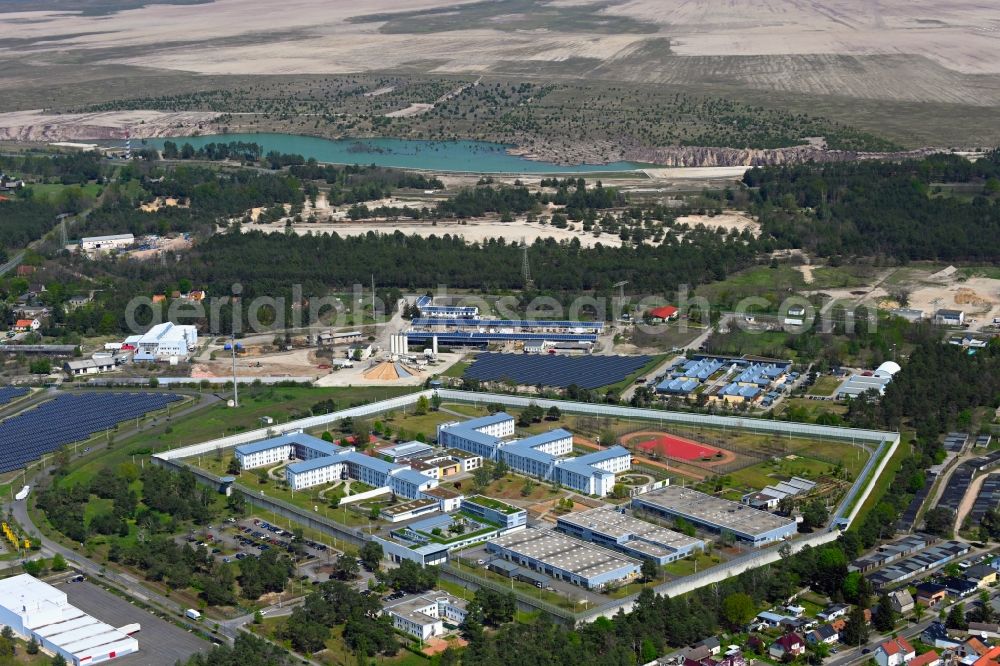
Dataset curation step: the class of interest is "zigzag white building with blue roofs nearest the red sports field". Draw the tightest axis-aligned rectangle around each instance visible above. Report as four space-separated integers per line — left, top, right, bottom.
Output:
438 412 632 497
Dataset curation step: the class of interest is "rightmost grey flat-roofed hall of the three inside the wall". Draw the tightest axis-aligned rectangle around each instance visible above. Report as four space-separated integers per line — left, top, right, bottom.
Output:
632 486 797 546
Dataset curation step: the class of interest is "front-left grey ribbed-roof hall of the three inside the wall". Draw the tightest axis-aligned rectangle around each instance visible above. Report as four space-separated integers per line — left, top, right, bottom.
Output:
486 527 641 589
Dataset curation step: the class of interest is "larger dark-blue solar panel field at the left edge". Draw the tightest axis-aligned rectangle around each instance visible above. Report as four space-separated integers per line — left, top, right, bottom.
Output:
0 393 181 473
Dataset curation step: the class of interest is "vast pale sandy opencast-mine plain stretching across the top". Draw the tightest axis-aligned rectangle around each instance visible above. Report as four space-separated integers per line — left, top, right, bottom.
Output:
0 0 1000 105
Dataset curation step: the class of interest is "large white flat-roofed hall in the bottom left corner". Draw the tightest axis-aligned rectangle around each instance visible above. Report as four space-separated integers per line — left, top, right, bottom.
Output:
0 574 139 666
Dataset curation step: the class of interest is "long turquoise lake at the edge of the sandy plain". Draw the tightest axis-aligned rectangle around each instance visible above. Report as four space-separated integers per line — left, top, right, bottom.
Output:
141 133 642 173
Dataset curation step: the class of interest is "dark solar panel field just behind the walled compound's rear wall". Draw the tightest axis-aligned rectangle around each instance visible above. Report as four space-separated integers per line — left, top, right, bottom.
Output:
465 352 653 389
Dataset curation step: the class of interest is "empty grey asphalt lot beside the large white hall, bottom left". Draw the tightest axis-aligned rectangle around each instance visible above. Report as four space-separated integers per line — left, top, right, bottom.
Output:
57 581 212 666
